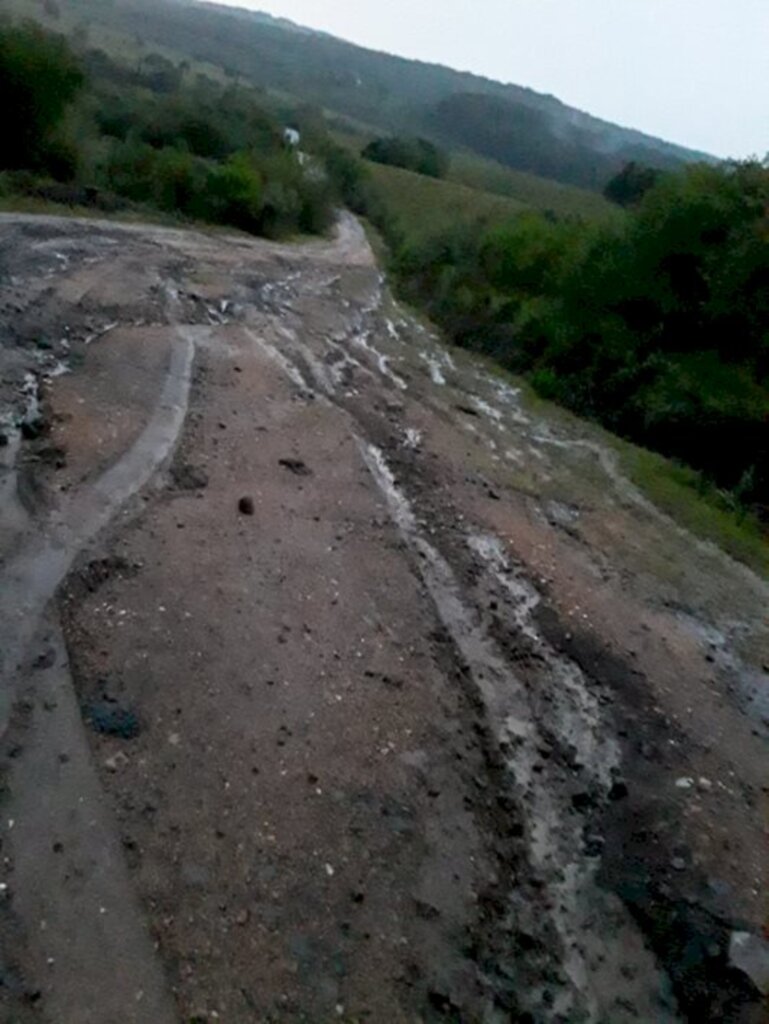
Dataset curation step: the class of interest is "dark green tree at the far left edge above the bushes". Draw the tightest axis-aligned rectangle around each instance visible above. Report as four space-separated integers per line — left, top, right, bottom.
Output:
0 25 84 170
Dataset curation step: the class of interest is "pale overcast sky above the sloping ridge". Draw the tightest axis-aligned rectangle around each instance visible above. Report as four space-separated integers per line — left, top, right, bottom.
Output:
202 0 769 157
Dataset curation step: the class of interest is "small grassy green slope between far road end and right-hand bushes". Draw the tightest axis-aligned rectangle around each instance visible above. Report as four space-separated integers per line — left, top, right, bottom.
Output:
368 164 524 244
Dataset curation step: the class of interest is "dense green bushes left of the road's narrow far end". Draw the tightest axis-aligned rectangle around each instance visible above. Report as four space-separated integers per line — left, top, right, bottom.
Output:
0 21 336 237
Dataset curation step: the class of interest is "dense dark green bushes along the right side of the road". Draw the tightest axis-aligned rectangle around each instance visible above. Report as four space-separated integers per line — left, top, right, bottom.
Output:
397 163 769 506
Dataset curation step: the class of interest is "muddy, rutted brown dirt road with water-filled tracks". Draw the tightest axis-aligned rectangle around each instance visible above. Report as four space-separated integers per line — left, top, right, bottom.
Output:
0 211 769 1024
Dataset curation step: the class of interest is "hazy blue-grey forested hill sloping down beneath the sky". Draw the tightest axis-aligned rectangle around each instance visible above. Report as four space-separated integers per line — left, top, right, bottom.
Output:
12 0 712 190
